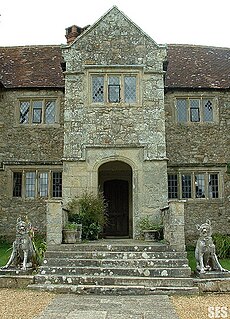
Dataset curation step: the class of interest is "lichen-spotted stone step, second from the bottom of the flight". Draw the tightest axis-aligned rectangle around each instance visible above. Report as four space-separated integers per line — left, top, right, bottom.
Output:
34 274 193 287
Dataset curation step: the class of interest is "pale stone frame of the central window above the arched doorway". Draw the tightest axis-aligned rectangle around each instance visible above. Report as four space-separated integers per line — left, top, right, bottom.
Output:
85 65 143 107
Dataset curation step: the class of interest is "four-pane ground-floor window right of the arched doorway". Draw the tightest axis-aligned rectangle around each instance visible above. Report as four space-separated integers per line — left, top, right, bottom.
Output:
168 172 220 199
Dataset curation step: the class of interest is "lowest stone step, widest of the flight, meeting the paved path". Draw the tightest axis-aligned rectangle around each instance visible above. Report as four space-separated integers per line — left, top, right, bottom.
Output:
28 284 198 295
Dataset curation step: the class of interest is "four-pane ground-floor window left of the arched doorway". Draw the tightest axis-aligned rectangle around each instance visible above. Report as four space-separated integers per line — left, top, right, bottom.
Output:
13 169 62 198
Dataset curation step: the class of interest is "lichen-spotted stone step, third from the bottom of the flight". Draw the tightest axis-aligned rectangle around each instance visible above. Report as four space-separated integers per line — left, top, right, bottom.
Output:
40 266 191 277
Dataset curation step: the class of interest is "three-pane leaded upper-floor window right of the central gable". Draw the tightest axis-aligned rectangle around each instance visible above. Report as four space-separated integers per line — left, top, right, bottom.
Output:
176 98 214 123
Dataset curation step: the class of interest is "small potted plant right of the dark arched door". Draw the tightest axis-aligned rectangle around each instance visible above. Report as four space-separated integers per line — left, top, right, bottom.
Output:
139 216 164 241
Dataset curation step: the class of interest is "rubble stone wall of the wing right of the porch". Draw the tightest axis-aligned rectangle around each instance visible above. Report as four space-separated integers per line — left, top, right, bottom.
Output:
165 91 230 243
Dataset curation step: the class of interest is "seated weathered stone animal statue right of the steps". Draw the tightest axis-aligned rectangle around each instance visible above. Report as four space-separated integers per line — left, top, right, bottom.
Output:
195 219 228 273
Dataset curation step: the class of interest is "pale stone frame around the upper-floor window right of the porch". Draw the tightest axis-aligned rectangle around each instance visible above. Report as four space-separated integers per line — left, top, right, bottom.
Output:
173 93 219 125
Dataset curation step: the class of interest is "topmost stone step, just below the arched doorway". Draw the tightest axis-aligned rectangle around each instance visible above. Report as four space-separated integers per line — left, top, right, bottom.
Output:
47 244 172 252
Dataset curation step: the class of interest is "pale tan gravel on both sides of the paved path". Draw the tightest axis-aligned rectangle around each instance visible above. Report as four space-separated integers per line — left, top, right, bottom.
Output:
0 289 230 319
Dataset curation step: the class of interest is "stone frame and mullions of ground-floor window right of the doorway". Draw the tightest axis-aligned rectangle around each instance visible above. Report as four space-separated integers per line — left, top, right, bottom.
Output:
168 167 224 202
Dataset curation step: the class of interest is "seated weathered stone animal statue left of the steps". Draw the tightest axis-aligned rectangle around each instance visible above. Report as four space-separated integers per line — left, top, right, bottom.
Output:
2 217 36 270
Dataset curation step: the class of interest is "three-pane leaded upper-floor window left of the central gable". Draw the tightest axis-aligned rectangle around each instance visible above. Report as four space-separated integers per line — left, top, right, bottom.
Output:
19 99 57 124
